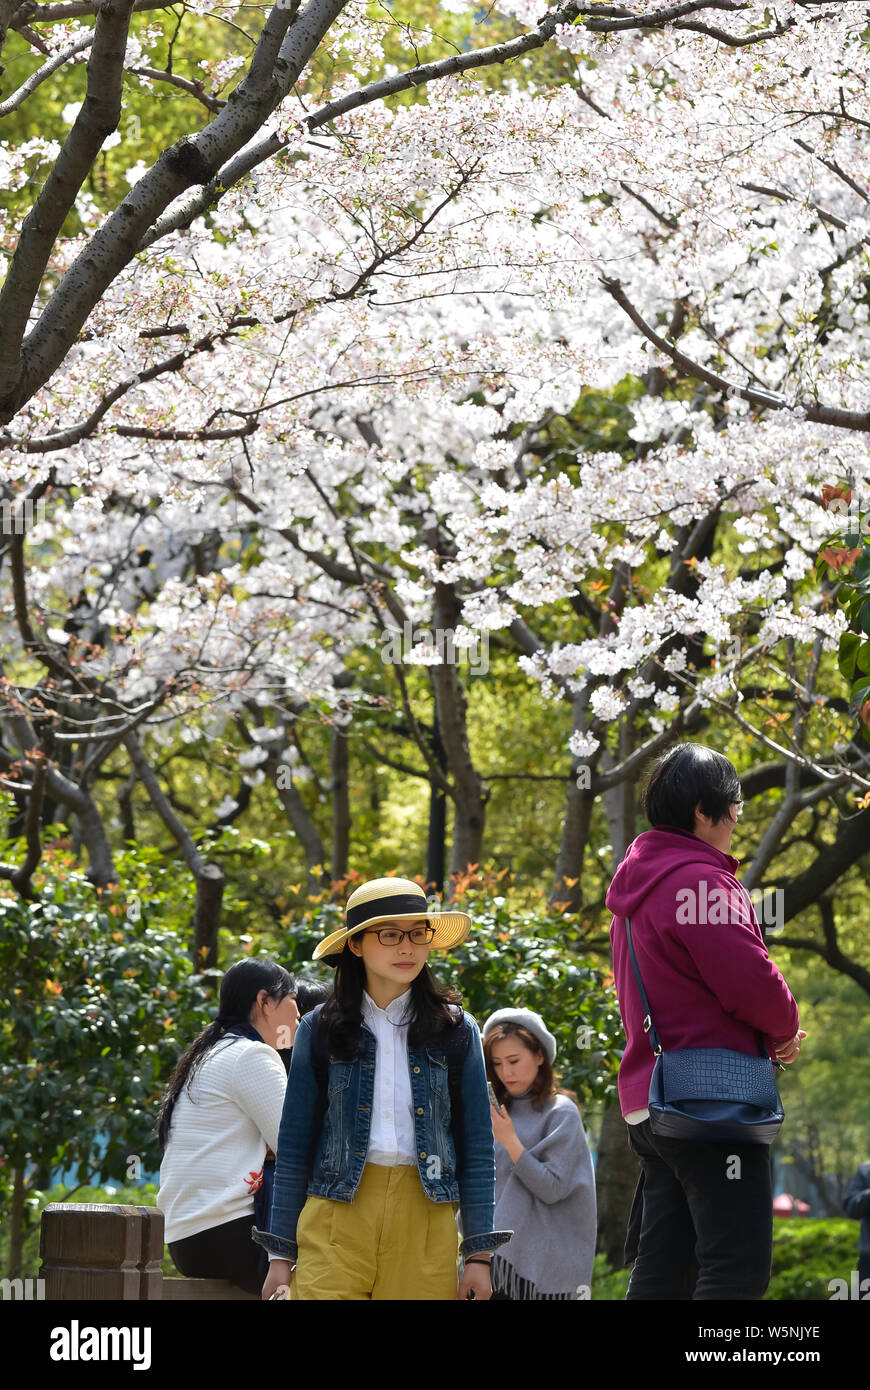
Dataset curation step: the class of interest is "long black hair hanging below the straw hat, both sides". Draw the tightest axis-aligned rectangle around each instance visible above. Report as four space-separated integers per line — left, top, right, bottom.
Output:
321 942 461 1062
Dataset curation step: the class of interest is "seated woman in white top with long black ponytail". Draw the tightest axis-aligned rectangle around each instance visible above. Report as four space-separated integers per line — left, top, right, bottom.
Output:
157 959 293 1294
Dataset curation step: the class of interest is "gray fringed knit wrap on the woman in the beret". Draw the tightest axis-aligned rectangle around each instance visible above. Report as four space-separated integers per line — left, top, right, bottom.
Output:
493 1095 596 1298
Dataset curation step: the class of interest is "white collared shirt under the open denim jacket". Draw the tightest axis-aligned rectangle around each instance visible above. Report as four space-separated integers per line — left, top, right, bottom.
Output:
363 988 417 1168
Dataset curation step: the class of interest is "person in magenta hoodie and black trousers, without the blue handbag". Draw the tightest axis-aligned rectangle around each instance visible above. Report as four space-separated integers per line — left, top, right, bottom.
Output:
606 744 806 1300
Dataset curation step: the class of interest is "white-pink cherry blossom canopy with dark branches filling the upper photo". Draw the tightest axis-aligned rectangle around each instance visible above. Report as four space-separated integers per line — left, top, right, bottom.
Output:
1 3 867 934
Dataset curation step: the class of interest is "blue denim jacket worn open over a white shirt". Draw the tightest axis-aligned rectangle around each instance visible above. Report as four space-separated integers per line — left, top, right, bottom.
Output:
253 1013 511 1261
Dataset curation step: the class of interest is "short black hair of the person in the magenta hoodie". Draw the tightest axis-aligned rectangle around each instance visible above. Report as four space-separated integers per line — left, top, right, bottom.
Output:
642 744 742 830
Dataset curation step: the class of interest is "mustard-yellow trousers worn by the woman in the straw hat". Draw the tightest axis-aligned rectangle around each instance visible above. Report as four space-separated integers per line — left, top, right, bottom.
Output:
290 1163 459 1301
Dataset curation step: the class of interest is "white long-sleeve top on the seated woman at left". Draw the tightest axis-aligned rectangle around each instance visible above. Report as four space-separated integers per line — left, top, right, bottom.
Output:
157 1037 286 1244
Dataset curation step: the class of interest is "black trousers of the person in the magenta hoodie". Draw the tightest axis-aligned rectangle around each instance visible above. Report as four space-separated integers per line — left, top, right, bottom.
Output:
625 1120 773 1300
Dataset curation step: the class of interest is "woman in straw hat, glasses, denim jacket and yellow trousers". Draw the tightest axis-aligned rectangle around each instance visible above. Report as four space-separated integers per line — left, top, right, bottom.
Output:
254 878 510 1300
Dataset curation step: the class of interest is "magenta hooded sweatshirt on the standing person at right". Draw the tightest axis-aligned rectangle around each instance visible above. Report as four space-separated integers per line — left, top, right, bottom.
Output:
606 826 799 1115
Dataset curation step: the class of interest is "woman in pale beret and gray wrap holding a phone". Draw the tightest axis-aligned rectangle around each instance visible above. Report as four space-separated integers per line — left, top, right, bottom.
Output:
482 1009 596 1301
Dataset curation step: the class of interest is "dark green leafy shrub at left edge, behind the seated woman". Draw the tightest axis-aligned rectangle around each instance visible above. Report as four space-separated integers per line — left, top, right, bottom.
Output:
0 851 217 1269
